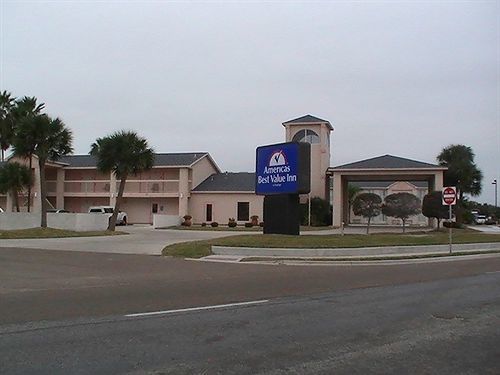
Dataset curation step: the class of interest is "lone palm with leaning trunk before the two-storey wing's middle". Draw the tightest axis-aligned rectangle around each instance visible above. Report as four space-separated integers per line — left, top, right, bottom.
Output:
90 131 155 230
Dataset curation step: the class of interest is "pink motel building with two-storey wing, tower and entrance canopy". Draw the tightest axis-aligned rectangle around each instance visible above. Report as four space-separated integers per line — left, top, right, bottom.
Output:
0 115 445 226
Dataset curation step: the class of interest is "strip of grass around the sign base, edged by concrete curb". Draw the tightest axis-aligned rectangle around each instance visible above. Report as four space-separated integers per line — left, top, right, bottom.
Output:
163 229 500 258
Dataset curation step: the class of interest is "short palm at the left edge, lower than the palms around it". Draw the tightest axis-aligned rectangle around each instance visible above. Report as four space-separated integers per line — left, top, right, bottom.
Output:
0 162 33 212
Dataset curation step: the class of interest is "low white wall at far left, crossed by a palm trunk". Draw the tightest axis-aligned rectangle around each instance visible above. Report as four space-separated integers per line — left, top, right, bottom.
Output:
0 212 108 232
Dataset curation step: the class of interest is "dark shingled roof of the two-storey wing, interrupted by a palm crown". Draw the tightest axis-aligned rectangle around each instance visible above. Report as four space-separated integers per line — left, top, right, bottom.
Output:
58 152 208 167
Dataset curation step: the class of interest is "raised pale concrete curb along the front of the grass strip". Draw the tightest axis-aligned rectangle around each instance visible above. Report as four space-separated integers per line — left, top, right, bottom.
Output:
212 242 500 258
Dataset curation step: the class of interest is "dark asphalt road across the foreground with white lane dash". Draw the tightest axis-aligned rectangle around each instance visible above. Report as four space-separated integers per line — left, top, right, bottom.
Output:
0 249 500 374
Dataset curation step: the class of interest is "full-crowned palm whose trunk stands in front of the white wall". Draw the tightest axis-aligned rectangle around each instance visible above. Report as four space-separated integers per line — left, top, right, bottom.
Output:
14 114 73 228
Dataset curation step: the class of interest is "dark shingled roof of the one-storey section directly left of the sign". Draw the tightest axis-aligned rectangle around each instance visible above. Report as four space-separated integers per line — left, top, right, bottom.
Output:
193 172 255 193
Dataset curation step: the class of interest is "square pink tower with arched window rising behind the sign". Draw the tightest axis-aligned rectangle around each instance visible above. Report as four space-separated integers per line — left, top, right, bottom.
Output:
283 115 333 200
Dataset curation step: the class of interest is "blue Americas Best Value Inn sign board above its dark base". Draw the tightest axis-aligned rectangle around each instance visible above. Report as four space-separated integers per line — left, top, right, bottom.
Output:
255 142 311 195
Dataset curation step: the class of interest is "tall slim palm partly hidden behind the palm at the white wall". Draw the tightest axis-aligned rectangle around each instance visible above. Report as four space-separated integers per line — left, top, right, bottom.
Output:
11 96 45 212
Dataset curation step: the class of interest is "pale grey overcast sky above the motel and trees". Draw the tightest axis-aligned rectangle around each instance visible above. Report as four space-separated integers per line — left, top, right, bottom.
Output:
0 0 500 203
